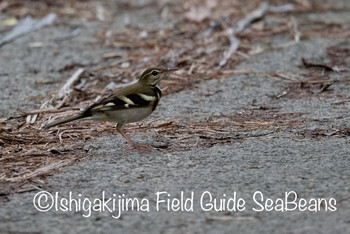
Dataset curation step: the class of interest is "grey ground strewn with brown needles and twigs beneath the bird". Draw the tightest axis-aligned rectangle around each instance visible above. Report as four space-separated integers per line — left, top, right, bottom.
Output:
0 0 350 234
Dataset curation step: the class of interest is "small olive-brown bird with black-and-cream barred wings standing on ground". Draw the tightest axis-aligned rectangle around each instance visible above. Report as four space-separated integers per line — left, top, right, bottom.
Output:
42 67 178 151
